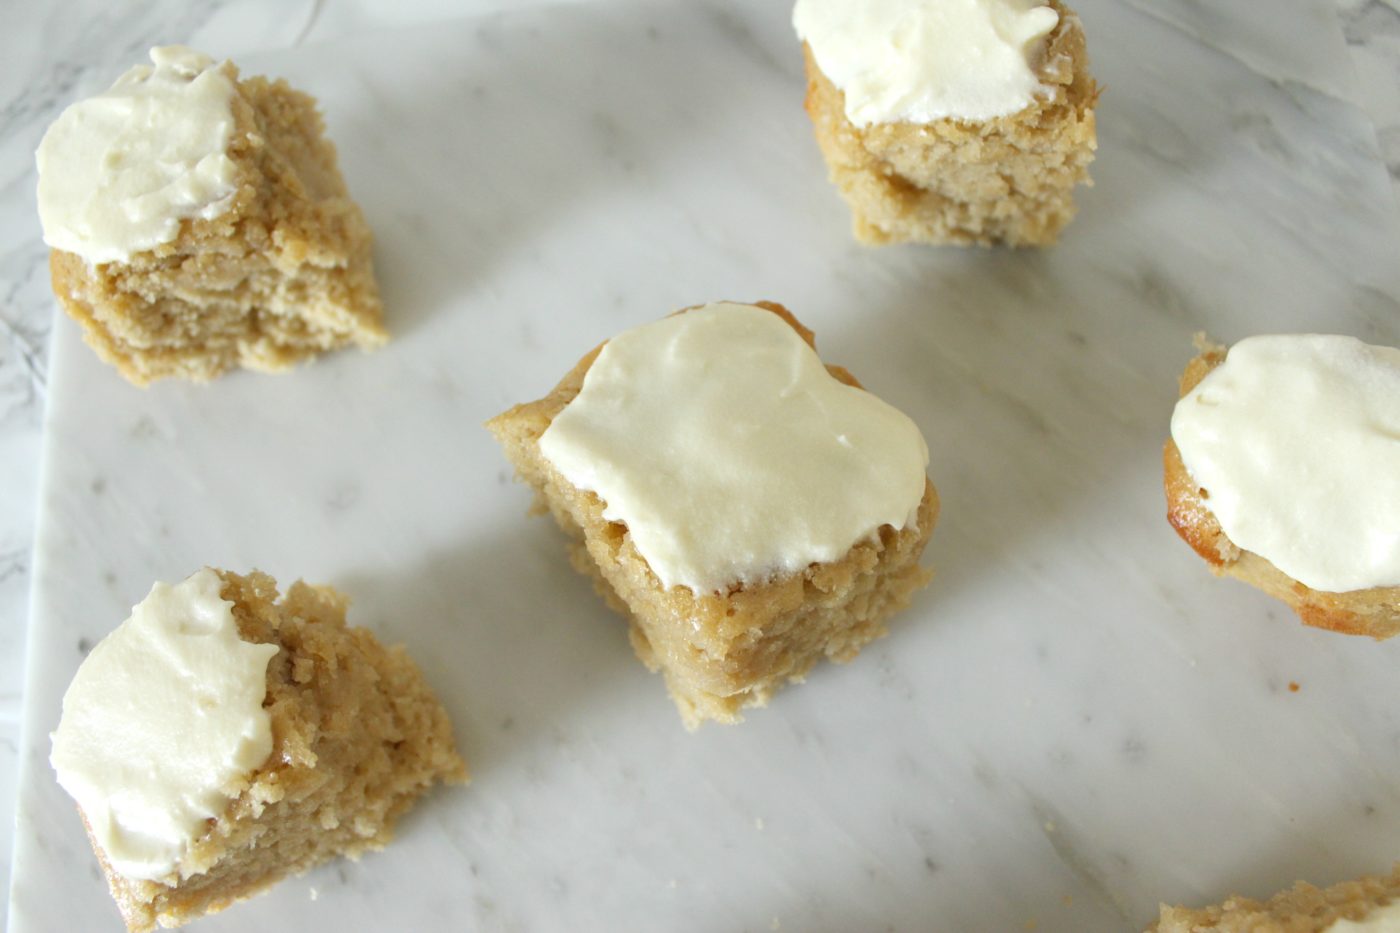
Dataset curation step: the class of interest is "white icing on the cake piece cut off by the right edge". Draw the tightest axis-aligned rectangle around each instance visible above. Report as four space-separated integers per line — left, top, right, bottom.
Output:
1172 335 1400 593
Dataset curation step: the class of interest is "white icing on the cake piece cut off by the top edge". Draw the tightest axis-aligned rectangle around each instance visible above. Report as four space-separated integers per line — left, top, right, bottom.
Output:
792 0 1060 126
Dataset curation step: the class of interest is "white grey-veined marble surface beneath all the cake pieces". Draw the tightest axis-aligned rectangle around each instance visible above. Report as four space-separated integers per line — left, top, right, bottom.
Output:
0 0 1400 930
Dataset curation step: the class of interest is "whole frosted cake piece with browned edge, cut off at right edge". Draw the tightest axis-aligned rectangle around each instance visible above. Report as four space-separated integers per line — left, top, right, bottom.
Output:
1163 333 1400 639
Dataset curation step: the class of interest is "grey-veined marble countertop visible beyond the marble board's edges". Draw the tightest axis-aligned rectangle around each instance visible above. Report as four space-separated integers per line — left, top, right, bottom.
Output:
0 0 1400 918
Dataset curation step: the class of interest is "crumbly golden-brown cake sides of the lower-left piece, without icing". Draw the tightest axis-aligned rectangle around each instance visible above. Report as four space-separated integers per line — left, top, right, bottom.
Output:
84 570 468 933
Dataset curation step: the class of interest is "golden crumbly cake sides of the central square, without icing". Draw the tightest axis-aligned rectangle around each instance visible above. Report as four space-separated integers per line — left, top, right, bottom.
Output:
487 301 938 728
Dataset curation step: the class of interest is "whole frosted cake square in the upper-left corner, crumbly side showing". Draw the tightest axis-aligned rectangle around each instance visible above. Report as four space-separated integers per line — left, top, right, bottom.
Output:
38 46 388 385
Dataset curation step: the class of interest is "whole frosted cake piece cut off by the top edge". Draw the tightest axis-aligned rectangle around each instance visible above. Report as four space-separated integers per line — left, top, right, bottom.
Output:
794 0 1099 247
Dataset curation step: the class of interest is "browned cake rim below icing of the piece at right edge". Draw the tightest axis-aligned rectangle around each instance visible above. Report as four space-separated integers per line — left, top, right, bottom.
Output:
1162 336 1400 639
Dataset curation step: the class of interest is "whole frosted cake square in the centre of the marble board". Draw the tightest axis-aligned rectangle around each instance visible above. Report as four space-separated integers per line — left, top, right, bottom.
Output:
487 303 938 728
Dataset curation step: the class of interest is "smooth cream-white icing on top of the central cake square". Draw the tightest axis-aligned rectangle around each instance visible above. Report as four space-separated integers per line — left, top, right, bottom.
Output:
540 303 928 593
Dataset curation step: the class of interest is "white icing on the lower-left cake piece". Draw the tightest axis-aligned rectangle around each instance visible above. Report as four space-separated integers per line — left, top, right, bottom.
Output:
49 569 277 878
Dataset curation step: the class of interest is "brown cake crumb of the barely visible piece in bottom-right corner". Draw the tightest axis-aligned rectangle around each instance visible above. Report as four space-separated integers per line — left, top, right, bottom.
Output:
1148 863 1400 933
